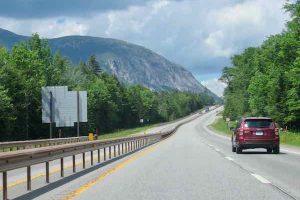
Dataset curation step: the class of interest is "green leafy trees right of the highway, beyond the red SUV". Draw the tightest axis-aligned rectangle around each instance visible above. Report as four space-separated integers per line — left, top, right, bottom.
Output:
220 0 300 130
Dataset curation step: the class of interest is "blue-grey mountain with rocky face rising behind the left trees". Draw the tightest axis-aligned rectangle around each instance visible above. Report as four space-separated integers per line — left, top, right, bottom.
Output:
0 29 217 98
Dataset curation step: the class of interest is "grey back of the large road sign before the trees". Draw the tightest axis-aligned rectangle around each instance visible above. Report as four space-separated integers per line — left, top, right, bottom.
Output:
42 86 87 127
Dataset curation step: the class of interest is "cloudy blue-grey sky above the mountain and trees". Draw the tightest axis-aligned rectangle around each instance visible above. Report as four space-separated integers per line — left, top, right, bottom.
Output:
0 0 289 96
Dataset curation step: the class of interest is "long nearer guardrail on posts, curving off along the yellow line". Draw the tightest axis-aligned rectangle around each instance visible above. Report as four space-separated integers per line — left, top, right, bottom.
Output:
0 113 202 200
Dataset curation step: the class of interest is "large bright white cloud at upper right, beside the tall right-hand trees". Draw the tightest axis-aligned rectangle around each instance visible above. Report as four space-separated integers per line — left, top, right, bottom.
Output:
208 0 288 53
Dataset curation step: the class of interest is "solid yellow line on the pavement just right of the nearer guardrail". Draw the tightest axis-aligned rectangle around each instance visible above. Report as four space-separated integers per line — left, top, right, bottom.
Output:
62 140 166 200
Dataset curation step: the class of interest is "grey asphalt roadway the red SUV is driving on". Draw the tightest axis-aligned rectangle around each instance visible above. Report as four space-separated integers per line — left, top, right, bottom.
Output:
0 108 300 200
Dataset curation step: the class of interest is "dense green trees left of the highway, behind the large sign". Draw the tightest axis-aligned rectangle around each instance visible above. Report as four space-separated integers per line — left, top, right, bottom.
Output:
0 34 213 141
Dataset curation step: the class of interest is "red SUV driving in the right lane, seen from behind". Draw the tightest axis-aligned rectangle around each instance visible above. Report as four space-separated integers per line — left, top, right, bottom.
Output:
231 117 280 154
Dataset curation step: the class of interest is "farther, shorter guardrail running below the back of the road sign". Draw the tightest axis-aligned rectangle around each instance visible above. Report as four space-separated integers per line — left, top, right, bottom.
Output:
0 136 89 152
